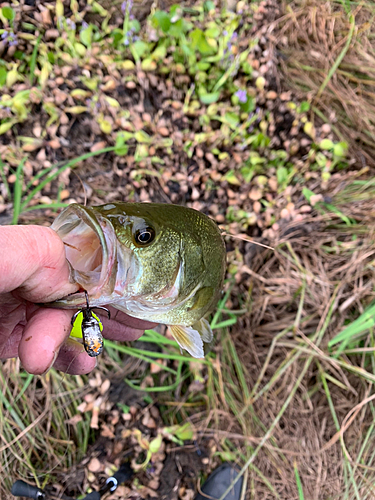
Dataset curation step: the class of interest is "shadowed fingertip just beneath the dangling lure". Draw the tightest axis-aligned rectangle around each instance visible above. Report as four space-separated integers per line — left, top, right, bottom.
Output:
53 338 96 375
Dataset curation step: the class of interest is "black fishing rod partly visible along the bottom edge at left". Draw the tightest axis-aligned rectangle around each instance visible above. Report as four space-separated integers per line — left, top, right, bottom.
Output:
11 463 134 500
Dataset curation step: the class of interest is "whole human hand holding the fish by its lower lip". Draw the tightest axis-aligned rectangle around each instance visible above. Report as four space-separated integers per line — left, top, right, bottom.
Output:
0 226 155 375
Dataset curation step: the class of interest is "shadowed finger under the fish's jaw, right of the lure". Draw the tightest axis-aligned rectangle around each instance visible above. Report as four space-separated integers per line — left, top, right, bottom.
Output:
100 307 157 342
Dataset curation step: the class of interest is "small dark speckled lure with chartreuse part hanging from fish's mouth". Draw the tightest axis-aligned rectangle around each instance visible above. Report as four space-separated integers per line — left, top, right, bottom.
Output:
72 291 111 358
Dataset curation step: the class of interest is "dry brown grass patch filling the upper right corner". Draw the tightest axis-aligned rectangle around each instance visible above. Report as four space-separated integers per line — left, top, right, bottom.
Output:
273 0 375 166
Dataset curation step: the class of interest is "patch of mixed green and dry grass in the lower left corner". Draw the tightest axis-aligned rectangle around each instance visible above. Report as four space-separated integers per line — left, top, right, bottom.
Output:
0 359 91 492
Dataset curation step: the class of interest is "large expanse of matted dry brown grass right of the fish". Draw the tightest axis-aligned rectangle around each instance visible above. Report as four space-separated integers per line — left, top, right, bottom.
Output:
194 174 375 500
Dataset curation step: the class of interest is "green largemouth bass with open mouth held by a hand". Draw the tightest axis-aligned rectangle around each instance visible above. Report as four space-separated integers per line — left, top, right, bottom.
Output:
49 202 226 358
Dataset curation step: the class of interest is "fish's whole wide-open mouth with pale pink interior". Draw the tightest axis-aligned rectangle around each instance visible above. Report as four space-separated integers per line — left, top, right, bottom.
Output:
51 204 117 308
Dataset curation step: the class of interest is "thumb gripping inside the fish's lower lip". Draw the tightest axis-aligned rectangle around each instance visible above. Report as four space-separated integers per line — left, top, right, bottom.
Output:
0 226 78 302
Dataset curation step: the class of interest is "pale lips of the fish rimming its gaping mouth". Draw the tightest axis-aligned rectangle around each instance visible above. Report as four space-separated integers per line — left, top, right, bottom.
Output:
51 204 117 308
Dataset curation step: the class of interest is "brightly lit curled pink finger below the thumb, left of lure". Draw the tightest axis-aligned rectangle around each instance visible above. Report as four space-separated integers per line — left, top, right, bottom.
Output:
18 308 72 374
